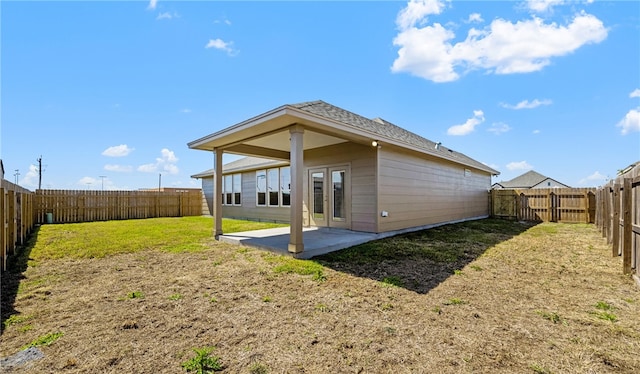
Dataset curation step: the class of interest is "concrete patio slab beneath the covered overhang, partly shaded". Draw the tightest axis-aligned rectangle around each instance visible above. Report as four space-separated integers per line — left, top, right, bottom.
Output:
220 227 387 259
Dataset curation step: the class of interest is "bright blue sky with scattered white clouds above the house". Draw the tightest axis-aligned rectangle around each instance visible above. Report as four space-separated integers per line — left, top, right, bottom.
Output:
0 0 640 190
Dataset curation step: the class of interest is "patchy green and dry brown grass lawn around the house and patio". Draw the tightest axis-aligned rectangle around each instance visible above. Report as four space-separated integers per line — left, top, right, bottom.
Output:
0 217 640 373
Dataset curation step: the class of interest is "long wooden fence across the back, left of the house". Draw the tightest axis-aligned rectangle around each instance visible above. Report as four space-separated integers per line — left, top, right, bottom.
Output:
33 190 202 223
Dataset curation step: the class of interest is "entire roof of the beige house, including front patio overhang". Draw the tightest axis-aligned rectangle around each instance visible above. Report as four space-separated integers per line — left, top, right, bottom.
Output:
188 100 500 175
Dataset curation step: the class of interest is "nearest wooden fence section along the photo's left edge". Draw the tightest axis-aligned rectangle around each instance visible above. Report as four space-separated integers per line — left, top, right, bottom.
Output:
0 179 35 271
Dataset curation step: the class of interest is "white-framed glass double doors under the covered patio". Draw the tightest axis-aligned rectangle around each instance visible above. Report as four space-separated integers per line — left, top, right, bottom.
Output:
309 166 351 229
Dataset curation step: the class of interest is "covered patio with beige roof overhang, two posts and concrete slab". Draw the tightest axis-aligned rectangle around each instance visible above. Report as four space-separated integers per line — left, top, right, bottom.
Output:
189 102 378 258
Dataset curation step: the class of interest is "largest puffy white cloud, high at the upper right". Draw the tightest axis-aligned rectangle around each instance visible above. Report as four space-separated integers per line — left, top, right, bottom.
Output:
391 2 607 82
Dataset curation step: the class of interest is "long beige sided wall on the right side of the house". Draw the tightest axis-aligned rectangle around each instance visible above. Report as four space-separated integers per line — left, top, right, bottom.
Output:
378 146 491 232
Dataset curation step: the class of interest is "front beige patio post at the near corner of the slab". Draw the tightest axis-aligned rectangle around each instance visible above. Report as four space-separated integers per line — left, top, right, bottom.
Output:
288 125 304 253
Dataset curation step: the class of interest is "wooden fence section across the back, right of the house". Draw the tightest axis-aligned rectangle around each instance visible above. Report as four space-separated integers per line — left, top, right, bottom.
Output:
491 188 596 223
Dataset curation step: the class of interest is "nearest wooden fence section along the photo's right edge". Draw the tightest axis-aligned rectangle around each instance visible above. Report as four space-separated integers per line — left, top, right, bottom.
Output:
596 163 640 277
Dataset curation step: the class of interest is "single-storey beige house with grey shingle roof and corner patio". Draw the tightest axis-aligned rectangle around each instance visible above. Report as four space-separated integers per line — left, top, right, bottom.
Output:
188 101 498 253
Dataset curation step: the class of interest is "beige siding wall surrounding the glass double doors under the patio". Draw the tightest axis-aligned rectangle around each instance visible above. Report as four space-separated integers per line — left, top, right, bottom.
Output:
303 143 377 232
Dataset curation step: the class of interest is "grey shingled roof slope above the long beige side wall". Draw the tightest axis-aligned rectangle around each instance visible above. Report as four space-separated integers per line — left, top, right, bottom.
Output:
288 100 499 174
